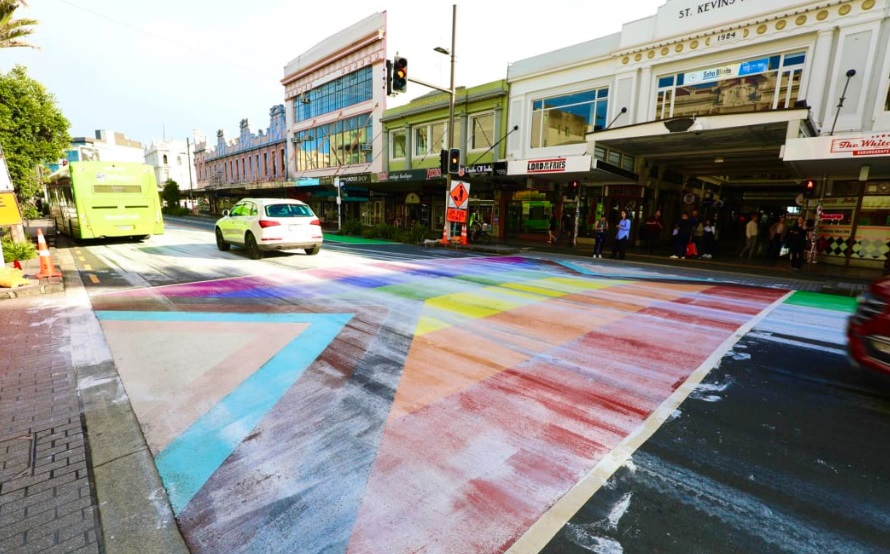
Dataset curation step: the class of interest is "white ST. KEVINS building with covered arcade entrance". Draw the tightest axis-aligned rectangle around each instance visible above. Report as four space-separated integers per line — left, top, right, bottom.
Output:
507 0 890 265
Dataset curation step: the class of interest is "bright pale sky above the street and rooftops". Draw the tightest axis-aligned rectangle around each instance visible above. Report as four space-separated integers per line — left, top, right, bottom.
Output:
0 0 667 145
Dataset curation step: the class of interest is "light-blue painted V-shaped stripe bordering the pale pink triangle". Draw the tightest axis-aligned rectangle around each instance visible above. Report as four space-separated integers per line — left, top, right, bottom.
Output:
96 311 352 516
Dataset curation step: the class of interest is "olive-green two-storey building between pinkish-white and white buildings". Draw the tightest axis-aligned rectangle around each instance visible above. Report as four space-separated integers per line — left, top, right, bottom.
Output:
378 80 508 236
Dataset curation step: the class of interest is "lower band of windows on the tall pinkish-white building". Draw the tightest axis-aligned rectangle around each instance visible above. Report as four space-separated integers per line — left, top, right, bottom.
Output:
294 113 374 171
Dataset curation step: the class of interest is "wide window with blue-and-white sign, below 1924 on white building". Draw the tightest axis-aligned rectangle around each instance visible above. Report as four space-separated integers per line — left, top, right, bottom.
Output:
656 52 806 119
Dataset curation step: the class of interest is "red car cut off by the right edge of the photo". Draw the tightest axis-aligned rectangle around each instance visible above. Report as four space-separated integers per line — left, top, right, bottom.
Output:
847 276 890 383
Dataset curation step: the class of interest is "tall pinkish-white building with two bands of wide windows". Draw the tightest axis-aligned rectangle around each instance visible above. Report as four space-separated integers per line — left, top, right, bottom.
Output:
281 12 386 225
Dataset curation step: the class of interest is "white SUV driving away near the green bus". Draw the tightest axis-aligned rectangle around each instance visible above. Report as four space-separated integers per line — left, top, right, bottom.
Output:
216 198 324 260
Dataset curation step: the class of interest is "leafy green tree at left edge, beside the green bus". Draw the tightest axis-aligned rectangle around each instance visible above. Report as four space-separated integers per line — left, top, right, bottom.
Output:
0 64 71 204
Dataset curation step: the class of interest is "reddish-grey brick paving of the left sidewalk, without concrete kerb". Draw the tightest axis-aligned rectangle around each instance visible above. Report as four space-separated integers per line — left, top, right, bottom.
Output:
0 292 101 553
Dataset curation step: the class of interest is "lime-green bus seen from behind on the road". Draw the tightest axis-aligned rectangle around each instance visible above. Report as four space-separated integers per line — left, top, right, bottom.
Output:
46 162 164 240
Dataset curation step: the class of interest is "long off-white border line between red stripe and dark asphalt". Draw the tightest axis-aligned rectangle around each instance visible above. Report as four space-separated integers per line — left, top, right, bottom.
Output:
507 291 794 554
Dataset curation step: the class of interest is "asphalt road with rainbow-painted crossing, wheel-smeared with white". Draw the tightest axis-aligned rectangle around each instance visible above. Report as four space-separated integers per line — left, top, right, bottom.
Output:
69 224 890 552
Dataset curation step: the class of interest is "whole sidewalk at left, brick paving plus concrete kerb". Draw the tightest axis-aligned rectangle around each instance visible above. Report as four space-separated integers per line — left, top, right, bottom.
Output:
0 244 188 554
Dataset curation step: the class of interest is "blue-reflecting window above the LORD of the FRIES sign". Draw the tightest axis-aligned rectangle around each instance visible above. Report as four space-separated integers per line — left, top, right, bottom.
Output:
531 87 609 148
